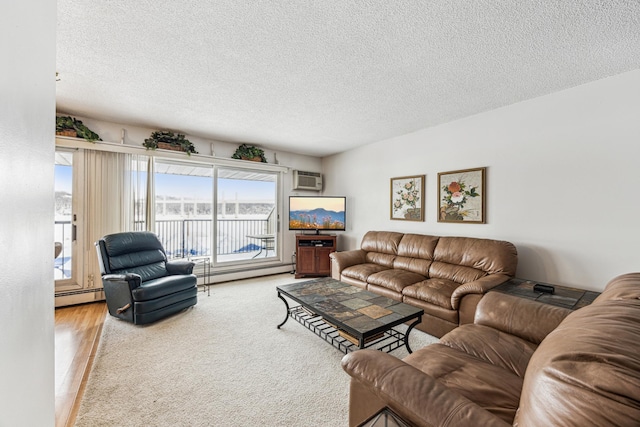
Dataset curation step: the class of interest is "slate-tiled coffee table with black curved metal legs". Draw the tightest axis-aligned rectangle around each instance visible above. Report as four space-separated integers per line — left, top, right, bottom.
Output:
276 278 424 354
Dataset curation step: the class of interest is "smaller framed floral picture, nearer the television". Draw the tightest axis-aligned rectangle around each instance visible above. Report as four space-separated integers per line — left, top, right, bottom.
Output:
391 175 424 221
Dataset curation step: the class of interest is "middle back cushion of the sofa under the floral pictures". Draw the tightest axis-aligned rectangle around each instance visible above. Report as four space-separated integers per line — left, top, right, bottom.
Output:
393 234 439 277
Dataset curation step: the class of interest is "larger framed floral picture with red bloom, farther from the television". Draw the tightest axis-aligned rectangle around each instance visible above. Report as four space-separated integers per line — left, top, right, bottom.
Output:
438 168 486 224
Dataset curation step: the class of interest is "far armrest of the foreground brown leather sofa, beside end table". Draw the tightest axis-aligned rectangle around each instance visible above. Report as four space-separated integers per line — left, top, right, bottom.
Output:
474 291 571 344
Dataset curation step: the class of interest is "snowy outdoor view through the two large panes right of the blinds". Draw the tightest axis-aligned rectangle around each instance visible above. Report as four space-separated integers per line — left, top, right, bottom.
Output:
155 169 276 261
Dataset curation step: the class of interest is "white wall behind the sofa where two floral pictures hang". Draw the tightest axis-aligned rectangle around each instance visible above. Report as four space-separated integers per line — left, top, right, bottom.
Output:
323 70 640 290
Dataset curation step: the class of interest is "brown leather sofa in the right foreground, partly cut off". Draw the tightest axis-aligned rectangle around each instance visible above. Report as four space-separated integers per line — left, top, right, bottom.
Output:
342 273 640 427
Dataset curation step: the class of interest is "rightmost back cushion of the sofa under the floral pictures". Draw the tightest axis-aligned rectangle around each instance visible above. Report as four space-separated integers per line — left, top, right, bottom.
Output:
429 237 518 284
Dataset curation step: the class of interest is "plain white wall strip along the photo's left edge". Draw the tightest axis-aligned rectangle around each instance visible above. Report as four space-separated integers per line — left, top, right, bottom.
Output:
0 0 56 426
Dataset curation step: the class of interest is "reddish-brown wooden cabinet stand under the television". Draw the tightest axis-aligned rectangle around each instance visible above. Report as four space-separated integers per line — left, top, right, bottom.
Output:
296 234 336 279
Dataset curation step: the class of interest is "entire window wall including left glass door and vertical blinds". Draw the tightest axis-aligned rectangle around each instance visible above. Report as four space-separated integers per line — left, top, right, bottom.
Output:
53 138 287 304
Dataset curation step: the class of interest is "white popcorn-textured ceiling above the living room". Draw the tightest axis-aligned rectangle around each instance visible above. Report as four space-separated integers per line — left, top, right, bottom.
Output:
56 0 640 156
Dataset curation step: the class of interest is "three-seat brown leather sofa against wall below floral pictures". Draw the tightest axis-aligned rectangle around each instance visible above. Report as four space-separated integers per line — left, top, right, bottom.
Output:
330 231 518 337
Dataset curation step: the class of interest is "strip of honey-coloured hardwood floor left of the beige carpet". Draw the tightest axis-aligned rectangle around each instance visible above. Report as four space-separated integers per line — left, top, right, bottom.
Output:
55 301 107 427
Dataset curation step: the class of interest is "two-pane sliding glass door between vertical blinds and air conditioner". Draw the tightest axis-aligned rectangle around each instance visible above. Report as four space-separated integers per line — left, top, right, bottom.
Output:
153 160 279 266
